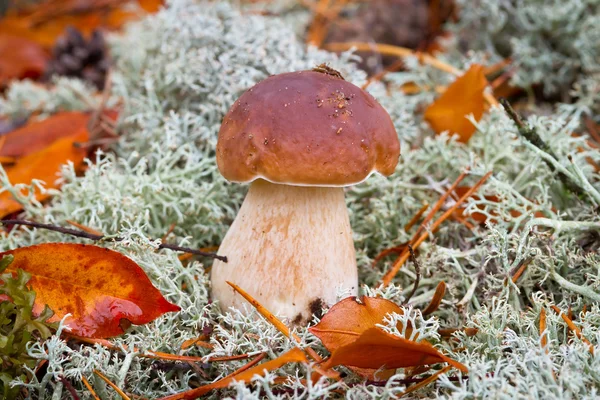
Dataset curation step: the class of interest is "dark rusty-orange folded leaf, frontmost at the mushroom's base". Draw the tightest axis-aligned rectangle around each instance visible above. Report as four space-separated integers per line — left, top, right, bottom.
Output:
321 327 468 372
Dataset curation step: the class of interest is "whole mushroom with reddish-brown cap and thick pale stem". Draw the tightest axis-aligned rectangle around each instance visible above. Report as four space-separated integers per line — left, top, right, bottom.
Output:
211 67 400 325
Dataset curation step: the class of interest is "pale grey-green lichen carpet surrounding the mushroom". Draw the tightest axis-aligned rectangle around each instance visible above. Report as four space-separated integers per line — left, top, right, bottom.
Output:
0 0 600 399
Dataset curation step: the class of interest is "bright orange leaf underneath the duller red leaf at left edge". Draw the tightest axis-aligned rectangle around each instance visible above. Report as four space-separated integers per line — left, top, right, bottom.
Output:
0 129 89 218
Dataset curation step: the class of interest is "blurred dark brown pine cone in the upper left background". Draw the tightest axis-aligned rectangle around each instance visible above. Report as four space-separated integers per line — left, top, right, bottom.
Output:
46 27 110 90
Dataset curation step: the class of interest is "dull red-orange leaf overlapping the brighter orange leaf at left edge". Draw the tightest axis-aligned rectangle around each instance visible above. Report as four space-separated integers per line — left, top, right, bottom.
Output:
0 111 90 158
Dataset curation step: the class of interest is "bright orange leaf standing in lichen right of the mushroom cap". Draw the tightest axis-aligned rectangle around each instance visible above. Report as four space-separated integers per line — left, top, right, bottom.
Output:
424 64 487 143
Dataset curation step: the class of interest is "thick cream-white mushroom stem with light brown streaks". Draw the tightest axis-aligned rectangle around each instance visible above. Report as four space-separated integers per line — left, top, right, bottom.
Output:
211 180 358 325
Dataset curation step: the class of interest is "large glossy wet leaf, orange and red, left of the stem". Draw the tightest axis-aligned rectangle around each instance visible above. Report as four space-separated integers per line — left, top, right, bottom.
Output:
0 243 180 338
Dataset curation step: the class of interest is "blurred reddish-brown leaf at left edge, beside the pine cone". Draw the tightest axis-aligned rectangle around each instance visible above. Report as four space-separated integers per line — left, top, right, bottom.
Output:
0 33 49 86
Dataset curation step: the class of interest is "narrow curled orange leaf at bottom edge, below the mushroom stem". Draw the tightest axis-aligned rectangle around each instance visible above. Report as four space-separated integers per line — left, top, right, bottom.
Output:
159 347 308 400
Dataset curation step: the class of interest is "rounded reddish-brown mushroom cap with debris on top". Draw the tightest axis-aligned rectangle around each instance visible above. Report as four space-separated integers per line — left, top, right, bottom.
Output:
217 71 400 186
